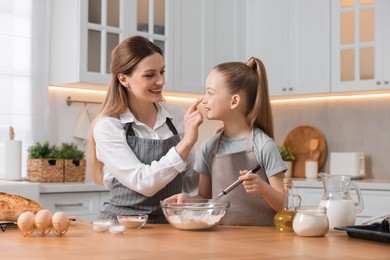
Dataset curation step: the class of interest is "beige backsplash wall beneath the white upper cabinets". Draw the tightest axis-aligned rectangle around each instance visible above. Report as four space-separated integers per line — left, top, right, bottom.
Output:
49 90 390 180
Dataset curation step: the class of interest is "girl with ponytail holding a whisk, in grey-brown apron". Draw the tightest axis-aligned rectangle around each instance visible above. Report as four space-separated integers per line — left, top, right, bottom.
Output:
166 58 286 225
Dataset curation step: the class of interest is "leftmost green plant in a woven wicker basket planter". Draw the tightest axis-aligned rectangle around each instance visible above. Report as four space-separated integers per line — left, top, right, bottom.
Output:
27 141 64 182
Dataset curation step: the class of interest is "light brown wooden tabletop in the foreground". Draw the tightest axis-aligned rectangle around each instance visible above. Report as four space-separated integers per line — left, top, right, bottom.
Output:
0 222 390 260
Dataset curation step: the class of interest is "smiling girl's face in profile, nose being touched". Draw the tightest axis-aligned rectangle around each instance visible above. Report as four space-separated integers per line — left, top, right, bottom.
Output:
203 70 232 121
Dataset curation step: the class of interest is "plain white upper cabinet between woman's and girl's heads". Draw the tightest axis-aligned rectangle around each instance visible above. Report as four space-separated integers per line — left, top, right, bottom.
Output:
170 0 245 93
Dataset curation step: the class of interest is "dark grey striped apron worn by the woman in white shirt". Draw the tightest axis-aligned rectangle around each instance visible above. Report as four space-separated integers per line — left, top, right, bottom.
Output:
100 118 183 223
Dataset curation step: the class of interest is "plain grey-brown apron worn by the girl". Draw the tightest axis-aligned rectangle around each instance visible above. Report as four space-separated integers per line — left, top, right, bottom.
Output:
211 131 276 226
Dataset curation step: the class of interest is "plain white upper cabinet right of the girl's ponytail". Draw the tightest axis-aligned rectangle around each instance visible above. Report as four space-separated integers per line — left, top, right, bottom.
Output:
245 0 330 96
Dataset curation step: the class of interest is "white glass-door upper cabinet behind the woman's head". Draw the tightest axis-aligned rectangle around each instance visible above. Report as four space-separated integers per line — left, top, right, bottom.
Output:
49 0 168 86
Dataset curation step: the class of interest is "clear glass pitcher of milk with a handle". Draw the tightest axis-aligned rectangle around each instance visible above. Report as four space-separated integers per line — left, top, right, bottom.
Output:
320 174 364 229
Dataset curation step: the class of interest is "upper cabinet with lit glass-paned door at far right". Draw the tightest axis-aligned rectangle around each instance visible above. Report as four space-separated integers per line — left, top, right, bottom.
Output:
332 0 390 92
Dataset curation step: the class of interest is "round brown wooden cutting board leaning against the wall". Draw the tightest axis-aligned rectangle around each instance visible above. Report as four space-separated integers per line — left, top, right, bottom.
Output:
283 126 327 178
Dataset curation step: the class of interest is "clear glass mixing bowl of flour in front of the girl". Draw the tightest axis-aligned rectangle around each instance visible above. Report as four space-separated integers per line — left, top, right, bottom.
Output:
160 199 230 230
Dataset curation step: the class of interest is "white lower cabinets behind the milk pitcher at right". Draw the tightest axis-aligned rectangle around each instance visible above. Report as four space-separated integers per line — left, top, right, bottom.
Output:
293 180 390 224
